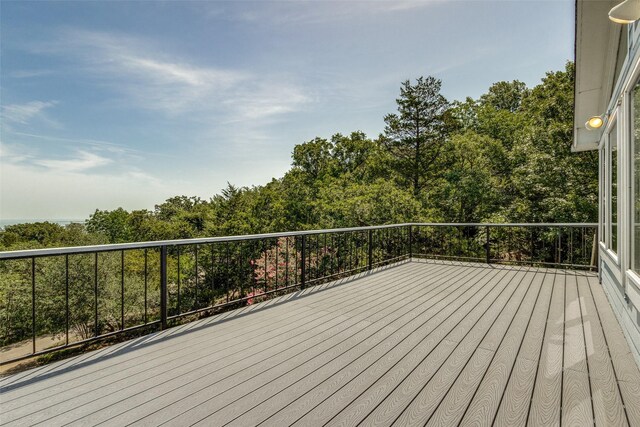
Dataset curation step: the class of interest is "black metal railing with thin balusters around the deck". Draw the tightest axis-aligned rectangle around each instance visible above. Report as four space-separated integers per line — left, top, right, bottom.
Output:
0 223 597 365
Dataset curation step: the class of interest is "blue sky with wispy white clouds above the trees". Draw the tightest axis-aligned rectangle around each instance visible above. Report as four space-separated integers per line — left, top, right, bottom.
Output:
0 0 574 219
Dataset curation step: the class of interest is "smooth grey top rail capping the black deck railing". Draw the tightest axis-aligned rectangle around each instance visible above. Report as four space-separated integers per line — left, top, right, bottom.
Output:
0 222 598 260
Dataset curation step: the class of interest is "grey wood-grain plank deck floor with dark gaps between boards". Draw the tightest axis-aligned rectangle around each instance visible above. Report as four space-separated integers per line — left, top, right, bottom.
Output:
0 261 640 426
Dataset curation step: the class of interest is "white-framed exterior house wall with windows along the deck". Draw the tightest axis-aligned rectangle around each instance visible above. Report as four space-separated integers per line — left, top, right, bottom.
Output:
599 23 640 366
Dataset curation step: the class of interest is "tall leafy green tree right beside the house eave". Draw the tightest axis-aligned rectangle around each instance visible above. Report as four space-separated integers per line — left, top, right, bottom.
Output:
504 62 598 222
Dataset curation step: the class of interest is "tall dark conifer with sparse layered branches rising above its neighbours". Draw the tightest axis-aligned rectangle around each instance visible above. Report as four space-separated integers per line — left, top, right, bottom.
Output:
382 76 449 197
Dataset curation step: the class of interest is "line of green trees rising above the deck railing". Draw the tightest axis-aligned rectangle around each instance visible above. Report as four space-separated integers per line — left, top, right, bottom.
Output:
0 63 598 250
